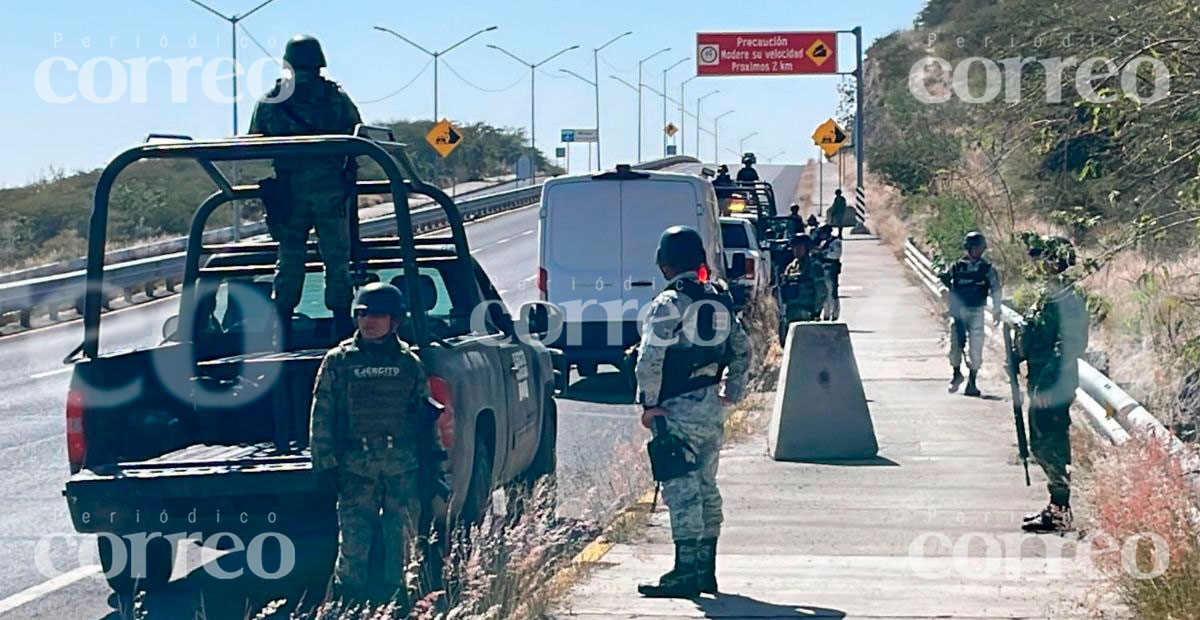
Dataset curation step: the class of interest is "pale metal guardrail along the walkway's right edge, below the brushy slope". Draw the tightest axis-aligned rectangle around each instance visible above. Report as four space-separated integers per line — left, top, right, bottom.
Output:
904 239 1171 443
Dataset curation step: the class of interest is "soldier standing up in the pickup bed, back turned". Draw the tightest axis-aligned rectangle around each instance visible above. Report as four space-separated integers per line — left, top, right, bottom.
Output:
250 35 362 338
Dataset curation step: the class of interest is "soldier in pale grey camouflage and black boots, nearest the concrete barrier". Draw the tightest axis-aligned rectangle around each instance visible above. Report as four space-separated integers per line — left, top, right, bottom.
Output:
635 227 750 598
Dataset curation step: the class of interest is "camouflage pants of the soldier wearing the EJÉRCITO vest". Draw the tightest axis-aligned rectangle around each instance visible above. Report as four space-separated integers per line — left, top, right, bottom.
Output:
334 452 421 598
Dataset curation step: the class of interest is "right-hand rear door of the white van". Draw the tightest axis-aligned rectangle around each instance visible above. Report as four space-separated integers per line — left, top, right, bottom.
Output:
620 177 702 320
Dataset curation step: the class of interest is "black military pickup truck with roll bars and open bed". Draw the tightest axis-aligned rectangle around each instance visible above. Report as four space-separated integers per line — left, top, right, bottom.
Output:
64 127 557 592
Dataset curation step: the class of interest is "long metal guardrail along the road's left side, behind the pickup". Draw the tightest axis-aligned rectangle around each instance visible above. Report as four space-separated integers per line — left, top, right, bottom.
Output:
0 156 696 327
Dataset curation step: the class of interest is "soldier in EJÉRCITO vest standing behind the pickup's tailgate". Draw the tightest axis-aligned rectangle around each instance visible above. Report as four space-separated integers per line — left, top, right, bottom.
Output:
310 282 449 600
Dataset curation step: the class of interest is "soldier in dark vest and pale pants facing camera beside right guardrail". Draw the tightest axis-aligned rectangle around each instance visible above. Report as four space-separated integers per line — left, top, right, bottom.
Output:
938 231 1003 396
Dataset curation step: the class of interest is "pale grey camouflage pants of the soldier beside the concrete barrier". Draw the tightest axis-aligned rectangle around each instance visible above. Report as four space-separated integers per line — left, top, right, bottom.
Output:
662 387 725 541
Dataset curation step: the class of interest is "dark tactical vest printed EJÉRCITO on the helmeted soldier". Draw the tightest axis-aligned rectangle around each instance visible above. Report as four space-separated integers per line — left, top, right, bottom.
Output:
346 360 418 450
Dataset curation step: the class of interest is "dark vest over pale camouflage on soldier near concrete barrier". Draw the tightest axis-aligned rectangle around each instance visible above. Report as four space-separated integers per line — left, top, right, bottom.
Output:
659 279 737 403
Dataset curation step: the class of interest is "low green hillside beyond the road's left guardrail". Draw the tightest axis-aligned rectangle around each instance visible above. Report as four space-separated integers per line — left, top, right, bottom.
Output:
0 121 553 270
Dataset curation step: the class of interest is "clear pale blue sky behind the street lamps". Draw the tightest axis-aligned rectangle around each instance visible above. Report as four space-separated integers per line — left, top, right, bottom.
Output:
0 0 924 186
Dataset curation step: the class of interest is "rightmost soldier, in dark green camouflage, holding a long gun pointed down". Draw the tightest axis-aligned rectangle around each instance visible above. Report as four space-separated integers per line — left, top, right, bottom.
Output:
1018 237 1090 531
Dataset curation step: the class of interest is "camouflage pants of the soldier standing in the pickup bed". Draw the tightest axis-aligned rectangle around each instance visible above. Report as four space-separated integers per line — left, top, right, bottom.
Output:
271 183 352 313
